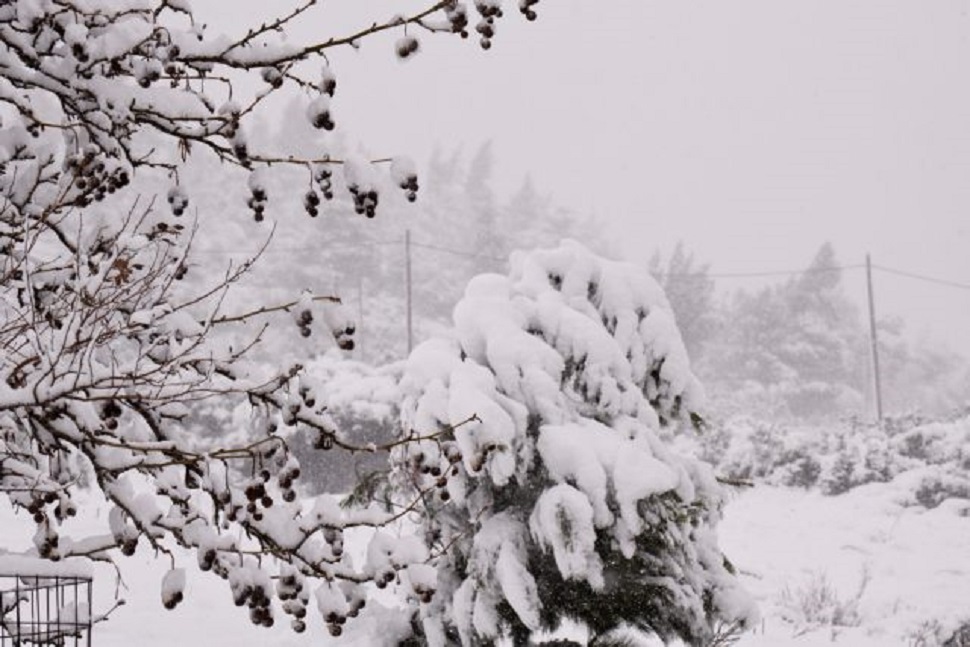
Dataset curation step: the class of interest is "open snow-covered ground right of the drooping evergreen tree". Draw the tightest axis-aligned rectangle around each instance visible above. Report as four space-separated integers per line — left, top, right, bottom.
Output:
720 478 970 647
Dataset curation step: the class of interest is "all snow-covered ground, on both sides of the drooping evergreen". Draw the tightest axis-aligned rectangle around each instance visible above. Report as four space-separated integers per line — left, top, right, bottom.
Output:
0 480 970 647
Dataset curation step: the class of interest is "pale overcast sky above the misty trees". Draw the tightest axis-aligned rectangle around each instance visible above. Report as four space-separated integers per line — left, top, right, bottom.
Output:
196 0 970 353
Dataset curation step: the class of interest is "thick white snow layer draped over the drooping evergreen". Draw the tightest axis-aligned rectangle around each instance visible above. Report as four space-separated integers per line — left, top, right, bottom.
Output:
395 241 754 644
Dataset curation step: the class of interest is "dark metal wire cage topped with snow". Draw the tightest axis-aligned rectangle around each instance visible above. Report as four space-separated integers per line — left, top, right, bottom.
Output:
0 573 92 647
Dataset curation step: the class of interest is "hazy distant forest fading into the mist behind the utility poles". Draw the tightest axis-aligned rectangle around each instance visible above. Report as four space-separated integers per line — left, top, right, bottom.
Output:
208 110 970 422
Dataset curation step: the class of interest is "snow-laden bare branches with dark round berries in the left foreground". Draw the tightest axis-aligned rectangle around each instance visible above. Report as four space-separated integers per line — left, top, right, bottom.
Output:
0 0 535 634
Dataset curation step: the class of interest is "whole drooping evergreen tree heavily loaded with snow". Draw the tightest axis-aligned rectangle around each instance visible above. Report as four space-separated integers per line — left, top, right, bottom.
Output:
393 242 754 645
